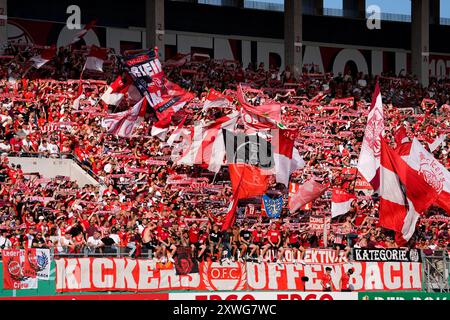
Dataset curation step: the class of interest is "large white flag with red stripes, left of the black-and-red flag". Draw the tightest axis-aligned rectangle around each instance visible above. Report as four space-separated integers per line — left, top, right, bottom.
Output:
177 112 239 173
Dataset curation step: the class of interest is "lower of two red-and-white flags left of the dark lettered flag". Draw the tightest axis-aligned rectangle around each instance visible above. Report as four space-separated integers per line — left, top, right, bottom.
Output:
102 98 147 138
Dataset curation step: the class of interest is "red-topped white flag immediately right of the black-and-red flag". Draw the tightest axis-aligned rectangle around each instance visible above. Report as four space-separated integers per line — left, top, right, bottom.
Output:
272 129 305 187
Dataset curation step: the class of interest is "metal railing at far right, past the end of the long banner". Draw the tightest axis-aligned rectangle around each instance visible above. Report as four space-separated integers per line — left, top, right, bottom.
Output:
422 251 450 293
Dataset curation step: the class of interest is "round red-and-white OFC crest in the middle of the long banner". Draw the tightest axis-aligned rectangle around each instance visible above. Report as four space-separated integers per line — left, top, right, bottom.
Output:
202 263 247 291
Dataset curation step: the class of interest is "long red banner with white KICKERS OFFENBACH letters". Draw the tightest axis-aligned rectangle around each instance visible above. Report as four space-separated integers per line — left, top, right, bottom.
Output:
56 258 422 292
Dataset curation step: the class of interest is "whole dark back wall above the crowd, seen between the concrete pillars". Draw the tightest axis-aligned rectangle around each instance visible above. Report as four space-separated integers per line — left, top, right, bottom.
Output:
8 0 450 78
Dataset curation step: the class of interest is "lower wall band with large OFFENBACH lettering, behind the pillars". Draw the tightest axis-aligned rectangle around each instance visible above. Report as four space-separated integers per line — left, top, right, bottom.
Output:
8 19 450 78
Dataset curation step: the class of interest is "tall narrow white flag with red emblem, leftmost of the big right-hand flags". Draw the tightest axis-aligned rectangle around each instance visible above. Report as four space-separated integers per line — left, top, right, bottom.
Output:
358 83 384 192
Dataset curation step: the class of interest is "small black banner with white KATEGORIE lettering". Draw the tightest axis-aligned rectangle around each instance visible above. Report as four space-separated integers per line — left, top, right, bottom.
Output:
353 249 422 262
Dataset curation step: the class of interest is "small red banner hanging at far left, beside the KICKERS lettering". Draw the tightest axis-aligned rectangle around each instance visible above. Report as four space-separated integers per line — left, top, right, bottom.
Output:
2 249 38 290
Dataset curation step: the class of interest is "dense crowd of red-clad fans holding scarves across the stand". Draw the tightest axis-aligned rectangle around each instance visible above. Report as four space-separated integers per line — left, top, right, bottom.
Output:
0 47 450 262
